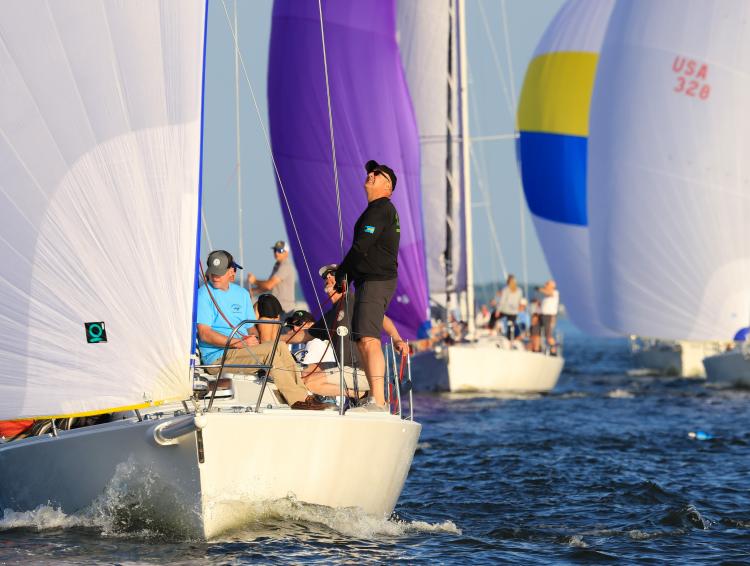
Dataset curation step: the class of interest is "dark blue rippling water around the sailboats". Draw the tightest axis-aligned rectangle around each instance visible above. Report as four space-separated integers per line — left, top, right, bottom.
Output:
0 331 750 565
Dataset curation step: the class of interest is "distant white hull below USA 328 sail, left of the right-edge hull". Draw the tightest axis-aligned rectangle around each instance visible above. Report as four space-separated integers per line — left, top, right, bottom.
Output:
633 340 723 378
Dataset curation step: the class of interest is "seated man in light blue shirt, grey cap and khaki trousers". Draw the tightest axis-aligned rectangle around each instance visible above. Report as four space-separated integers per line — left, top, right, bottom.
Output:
196 250 327 410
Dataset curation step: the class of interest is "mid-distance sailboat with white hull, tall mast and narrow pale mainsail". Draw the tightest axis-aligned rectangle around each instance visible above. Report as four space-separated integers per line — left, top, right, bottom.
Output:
398 0 564 392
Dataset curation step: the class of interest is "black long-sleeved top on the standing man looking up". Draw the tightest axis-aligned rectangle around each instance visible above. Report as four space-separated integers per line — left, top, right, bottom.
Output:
336 197 401 282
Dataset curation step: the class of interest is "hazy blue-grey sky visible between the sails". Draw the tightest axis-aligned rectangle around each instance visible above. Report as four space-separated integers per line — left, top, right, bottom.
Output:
202 0 563 290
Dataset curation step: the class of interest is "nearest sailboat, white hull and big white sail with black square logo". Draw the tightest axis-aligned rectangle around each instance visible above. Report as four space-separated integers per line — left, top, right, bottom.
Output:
0 0 421 538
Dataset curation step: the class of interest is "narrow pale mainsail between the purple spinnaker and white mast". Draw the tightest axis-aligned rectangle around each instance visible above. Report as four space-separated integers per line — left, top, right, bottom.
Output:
396 0 466 295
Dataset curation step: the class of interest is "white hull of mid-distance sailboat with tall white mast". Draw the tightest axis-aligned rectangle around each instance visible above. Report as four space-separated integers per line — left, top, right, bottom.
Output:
412 341 565 393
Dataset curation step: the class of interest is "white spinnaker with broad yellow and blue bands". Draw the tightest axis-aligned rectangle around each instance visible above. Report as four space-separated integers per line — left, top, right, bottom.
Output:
517 0 614 335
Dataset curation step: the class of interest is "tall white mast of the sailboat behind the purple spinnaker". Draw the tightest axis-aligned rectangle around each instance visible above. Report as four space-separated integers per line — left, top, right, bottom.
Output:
458 0 476 338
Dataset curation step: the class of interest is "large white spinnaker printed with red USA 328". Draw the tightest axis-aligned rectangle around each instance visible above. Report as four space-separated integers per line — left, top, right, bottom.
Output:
588 0 750 340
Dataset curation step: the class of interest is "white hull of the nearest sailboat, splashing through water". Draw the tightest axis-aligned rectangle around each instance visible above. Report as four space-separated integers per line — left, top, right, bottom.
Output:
0 386 421 539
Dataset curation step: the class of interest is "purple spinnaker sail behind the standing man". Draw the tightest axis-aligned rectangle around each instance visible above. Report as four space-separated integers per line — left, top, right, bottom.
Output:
268 0 428 338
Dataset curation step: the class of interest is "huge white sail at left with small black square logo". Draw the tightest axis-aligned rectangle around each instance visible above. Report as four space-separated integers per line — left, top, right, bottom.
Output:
0 0 206 418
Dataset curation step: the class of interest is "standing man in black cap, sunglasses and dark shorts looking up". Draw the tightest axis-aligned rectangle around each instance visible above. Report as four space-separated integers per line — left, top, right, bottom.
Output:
336 160 408 411
